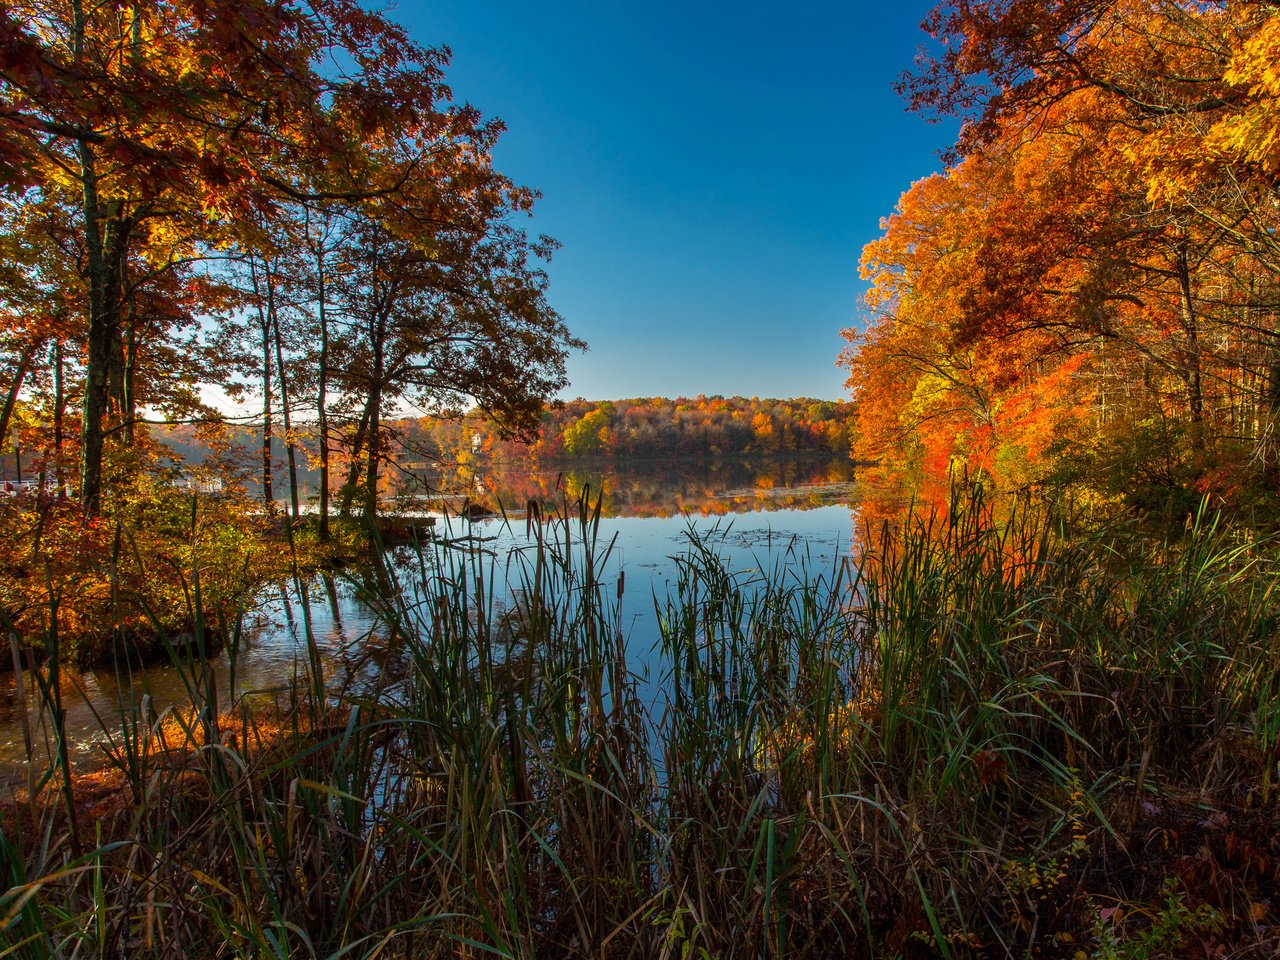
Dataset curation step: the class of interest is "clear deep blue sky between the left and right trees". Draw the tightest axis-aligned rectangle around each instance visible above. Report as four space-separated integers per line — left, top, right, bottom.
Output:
390 0 955 399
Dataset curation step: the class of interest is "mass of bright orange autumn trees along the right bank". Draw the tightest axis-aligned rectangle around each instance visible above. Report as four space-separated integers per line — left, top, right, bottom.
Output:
841 0 1280 506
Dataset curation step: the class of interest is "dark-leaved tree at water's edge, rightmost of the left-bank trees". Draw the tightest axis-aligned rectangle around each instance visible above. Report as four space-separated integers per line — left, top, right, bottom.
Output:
332 195 582 516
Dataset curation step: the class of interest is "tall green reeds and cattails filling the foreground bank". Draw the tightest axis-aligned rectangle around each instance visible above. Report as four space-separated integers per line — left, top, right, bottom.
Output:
0 490 1280 959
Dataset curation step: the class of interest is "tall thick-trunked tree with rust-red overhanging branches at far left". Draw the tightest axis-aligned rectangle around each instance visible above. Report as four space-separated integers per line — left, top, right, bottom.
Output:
0 0 479 513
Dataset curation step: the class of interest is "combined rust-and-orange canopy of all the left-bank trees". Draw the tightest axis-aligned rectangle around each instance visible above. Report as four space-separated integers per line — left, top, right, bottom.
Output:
0 0 581 515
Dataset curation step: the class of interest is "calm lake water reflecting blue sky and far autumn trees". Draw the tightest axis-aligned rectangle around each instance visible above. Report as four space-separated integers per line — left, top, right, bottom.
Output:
0 461 856 782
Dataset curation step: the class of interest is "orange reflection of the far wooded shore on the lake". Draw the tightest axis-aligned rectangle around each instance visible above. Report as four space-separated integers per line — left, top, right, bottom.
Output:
414 460 854 517
